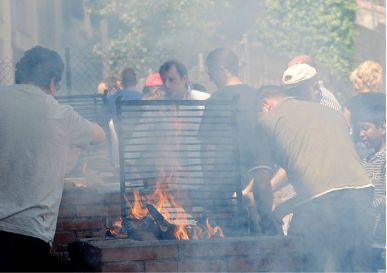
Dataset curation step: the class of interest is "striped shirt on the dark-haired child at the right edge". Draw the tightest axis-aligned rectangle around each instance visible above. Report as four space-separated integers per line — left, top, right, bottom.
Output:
363 148 386 244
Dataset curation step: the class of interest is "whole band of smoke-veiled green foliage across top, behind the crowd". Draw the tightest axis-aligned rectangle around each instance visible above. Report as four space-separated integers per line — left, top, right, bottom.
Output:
85 0 355 82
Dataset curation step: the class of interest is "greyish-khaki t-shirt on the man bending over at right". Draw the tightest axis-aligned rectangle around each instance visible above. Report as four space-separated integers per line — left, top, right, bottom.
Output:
261 98 372 202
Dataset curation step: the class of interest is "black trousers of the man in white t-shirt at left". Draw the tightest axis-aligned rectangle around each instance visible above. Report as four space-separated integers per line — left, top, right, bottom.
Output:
0 231 63 272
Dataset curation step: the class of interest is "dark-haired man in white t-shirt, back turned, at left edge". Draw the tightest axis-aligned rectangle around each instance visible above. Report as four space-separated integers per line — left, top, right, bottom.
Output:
0 46 105 271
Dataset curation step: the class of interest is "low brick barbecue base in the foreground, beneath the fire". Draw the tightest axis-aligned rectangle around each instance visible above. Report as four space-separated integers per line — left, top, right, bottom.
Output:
69 236 303 272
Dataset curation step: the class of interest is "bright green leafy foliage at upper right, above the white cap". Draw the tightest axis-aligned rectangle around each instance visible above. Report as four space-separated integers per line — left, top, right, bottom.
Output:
252 0 356 77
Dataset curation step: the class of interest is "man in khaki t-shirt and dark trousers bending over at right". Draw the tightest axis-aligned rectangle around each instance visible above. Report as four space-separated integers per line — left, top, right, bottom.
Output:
260 88 373 272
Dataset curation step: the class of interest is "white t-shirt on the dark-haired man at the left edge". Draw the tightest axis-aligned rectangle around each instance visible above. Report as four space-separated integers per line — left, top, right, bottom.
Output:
0 84 94 242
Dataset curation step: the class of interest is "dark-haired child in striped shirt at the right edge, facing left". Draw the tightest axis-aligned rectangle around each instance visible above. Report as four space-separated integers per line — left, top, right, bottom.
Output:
358 104 386 268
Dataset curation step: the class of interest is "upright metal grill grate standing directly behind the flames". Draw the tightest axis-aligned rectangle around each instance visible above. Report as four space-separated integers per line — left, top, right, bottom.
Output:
117 100 247 234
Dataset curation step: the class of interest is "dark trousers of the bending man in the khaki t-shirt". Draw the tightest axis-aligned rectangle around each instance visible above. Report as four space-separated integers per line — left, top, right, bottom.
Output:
289 188 373 272
